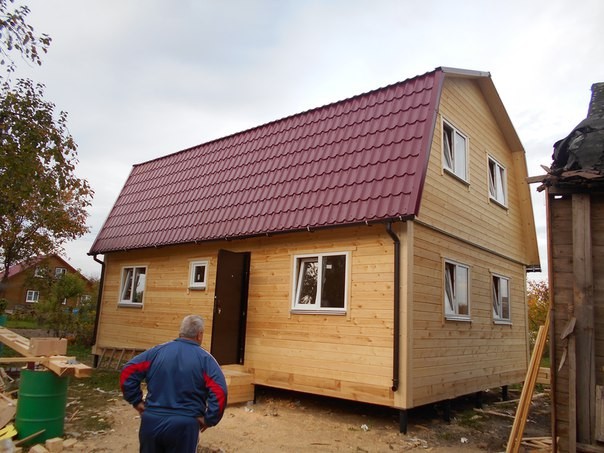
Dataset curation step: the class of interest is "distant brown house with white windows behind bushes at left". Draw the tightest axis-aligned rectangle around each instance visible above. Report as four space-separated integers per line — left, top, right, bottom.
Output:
1 254 91 311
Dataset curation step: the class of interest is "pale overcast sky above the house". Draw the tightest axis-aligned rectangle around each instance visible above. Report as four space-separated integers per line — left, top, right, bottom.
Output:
13 0 604 278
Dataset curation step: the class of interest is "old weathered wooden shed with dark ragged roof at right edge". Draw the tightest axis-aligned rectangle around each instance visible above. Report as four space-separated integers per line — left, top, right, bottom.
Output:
539 83 604 452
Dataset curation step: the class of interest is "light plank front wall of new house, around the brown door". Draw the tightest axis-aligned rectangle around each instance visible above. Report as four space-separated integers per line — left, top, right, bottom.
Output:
97 225 394 406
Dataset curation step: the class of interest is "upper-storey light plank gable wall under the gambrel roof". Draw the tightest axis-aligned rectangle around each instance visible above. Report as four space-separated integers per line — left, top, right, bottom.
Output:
418 78 536 264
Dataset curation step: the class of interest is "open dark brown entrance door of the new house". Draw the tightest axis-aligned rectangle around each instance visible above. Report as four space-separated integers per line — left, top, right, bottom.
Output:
211 250 250 365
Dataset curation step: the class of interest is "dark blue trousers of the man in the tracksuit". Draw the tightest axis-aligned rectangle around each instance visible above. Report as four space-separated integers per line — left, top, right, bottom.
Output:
138 411 199 453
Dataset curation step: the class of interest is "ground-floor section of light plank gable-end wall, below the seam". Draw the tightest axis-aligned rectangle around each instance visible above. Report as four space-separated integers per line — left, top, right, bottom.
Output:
410 225 528 406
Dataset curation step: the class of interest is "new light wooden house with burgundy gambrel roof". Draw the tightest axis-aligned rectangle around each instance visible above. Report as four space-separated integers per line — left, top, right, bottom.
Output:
89 68 539 425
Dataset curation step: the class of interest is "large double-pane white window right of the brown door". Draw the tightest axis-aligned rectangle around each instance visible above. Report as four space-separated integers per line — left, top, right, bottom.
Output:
293 253 348 312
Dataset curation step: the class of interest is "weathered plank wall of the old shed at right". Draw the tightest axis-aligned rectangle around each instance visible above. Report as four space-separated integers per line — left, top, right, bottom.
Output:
547 190 604 451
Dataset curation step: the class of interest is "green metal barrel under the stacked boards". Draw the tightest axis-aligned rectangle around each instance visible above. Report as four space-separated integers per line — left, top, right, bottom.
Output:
15 370 69 443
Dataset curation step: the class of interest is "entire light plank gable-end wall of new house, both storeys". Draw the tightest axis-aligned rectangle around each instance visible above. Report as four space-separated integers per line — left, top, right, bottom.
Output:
410 78 534 406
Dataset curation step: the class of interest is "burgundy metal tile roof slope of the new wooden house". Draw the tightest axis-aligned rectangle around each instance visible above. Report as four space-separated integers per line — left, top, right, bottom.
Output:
90 69 444 254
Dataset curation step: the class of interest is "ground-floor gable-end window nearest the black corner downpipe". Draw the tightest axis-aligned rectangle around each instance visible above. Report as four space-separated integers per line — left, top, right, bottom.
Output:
443 259 472 321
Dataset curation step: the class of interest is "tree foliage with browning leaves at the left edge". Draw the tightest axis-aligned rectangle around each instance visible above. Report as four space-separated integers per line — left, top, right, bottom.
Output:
0 0 93 288
